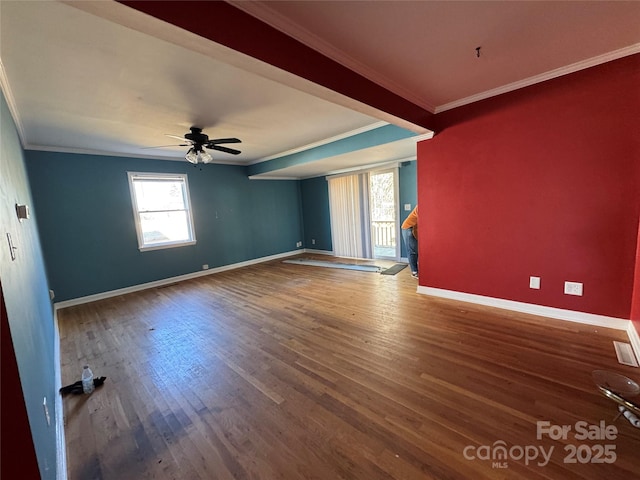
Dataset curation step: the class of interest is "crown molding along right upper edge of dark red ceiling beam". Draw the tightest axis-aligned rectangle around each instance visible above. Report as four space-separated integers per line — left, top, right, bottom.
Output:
228 0 435 113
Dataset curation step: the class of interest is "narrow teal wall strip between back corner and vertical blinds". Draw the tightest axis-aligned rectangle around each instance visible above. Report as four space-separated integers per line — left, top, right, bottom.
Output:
300 177 333 252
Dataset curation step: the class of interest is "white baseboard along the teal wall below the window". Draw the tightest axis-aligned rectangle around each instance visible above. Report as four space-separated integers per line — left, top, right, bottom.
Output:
54 249 304 309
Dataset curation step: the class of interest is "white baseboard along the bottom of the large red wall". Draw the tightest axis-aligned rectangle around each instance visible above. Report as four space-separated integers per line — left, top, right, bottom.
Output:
418 286 631 332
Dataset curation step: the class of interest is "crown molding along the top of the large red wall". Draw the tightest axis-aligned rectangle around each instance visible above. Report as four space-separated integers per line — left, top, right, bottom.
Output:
434 43 640 114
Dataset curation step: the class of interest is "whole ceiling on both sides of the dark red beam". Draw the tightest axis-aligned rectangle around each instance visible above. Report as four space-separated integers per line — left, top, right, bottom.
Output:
0 0 640 178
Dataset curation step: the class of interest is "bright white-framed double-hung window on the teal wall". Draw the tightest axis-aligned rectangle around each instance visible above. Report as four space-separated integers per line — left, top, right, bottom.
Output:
128 172 196 250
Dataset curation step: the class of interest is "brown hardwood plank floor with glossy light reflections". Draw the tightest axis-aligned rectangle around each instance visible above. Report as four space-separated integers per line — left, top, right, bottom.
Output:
58 257 640 480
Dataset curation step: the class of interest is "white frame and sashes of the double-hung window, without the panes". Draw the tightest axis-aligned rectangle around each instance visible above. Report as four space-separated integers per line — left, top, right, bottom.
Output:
127 172 196 252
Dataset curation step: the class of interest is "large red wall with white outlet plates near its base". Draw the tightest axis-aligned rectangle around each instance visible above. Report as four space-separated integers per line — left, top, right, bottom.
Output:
418 55 640 318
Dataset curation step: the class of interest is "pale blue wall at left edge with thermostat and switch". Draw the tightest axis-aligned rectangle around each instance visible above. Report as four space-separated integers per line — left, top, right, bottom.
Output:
0 95 58 479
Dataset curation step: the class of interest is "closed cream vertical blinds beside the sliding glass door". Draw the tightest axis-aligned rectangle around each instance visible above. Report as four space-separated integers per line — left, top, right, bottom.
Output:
328 173 371 258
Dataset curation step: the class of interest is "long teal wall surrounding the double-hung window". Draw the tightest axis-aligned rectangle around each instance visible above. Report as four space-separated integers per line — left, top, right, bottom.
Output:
26 151 303 301
